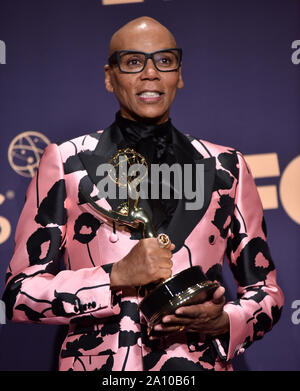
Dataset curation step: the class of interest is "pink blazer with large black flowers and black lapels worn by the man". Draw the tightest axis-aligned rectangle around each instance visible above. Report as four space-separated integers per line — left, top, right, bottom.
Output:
3 128 283 371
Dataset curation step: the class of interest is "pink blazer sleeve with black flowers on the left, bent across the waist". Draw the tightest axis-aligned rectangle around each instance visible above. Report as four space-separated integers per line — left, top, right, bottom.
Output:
3 144 120 324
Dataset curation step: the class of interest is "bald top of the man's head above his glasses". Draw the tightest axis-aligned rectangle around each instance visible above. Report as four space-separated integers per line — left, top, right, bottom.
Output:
109 16 177 55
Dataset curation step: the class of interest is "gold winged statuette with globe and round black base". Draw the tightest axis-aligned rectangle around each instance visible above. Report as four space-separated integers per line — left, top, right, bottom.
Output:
80 148 219 329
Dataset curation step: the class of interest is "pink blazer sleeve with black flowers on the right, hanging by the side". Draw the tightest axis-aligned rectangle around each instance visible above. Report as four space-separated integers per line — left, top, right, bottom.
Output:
219 152 284 360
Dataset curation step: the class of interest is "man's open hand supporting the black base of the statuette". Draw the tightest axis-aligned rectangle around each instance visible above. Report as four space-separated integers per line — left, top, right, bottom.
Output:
150 286 229 340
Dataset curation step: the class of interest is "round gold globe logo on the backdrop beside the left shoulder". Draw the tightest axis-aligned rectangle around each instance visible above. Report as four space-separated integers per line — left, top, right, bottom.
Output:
8 131 50 178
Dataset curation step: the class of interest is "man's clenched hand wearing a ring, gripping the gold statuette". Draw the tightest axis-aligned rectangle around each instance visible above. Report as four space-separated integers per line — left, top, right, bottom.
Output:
110 238 175 290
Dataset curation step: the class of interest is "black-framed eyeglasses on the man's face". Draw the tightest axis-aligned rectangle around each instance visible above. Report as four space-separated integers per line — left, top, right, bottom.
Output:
108 48 182 73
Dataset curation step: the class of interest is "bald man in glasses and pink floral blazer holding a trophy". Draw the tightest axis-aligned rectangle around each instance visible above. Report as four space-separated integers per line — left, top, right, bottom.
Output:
3 17 283 371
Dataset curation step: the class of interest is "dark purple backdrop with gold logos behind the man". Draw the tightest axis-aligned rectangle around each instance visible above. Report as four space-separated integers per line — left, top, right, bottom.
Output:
0 0 300 371
